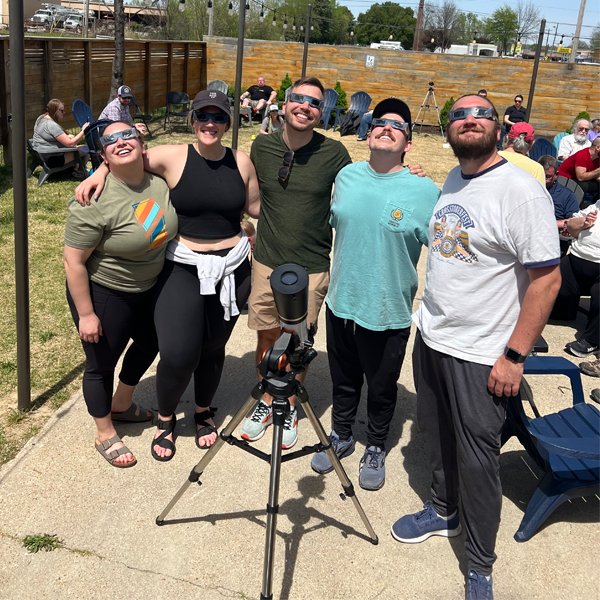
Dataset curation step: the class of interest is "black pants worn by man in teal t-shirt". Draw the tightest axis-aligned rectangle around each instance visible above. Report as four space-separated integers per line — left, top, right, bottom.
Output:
326 306 410 449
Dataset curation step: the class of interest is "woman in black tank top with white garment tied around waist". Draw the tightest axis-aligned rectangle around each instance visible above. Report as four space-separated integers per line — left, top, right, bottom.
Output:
74 90 260 461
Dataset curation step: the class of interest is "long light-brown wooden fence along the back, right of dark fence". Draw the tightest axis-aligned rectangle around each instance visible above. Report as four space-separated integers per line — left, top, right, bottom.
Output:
205 37 600 136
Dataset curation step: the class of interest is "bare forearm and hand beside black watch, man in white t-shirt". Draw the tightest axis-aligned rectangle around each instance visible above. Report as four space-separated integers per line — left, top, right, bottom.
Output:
488 264 561 396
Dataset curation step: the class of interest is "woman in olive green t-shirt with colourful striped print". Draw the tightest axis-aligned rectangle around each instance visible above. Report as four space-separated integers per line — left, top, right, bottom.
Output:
64 122 177 468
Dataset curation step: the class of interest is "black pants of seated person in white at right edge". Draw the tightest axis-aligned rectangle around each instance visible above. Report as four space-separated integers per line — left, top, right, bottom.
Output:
550 254 600 346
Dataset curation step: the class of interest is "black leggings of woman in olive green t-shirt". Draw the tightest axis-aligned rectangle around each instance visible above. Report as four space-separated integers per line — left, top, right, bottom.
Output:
67 281 158 419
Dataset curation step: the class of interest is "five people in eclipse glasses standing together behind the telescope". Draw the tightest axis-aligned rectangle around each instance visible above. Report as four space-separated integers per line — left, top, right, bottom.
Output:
71 77 560 599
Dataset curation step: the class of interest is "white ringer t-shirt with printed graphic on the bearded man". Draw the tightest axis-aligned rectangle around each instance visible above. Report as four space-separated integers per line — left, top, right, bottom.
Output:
413 160 560 365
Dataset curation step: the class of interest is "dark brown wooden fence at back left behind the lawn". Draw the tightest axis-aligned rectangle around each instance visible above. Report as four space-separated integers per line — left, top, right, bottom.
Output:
0 36 206 163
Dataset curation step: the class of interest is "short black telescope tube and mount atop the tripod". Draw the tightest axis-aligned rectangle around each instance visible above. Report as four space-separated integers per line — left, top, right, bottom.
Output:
258 263 317 379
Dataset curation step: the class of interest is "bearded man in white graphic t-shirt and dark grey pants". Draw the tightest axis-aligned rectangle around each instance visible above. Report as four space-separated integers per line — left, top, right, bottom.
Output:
392 95 560 600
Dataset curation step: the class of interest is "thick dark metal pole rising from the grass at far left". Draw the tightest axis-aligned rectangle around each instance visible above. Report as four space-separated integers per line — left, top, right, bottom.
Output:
9 0 31 410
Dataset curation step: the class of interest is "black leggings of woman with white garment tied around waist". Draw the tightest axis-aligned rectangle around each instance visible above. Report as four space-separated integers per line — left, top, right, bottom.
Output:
154 250 250 417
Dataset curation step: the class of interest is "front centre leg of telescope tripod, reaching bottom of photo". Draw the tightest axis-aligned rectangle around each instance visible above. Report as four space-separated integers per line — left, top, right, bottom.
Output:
260 398 290 600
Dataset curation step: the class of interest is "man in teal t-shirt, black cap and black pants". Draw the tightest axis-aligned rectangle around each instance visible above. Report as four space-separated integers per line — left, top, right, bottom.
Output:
312 98 440 490
